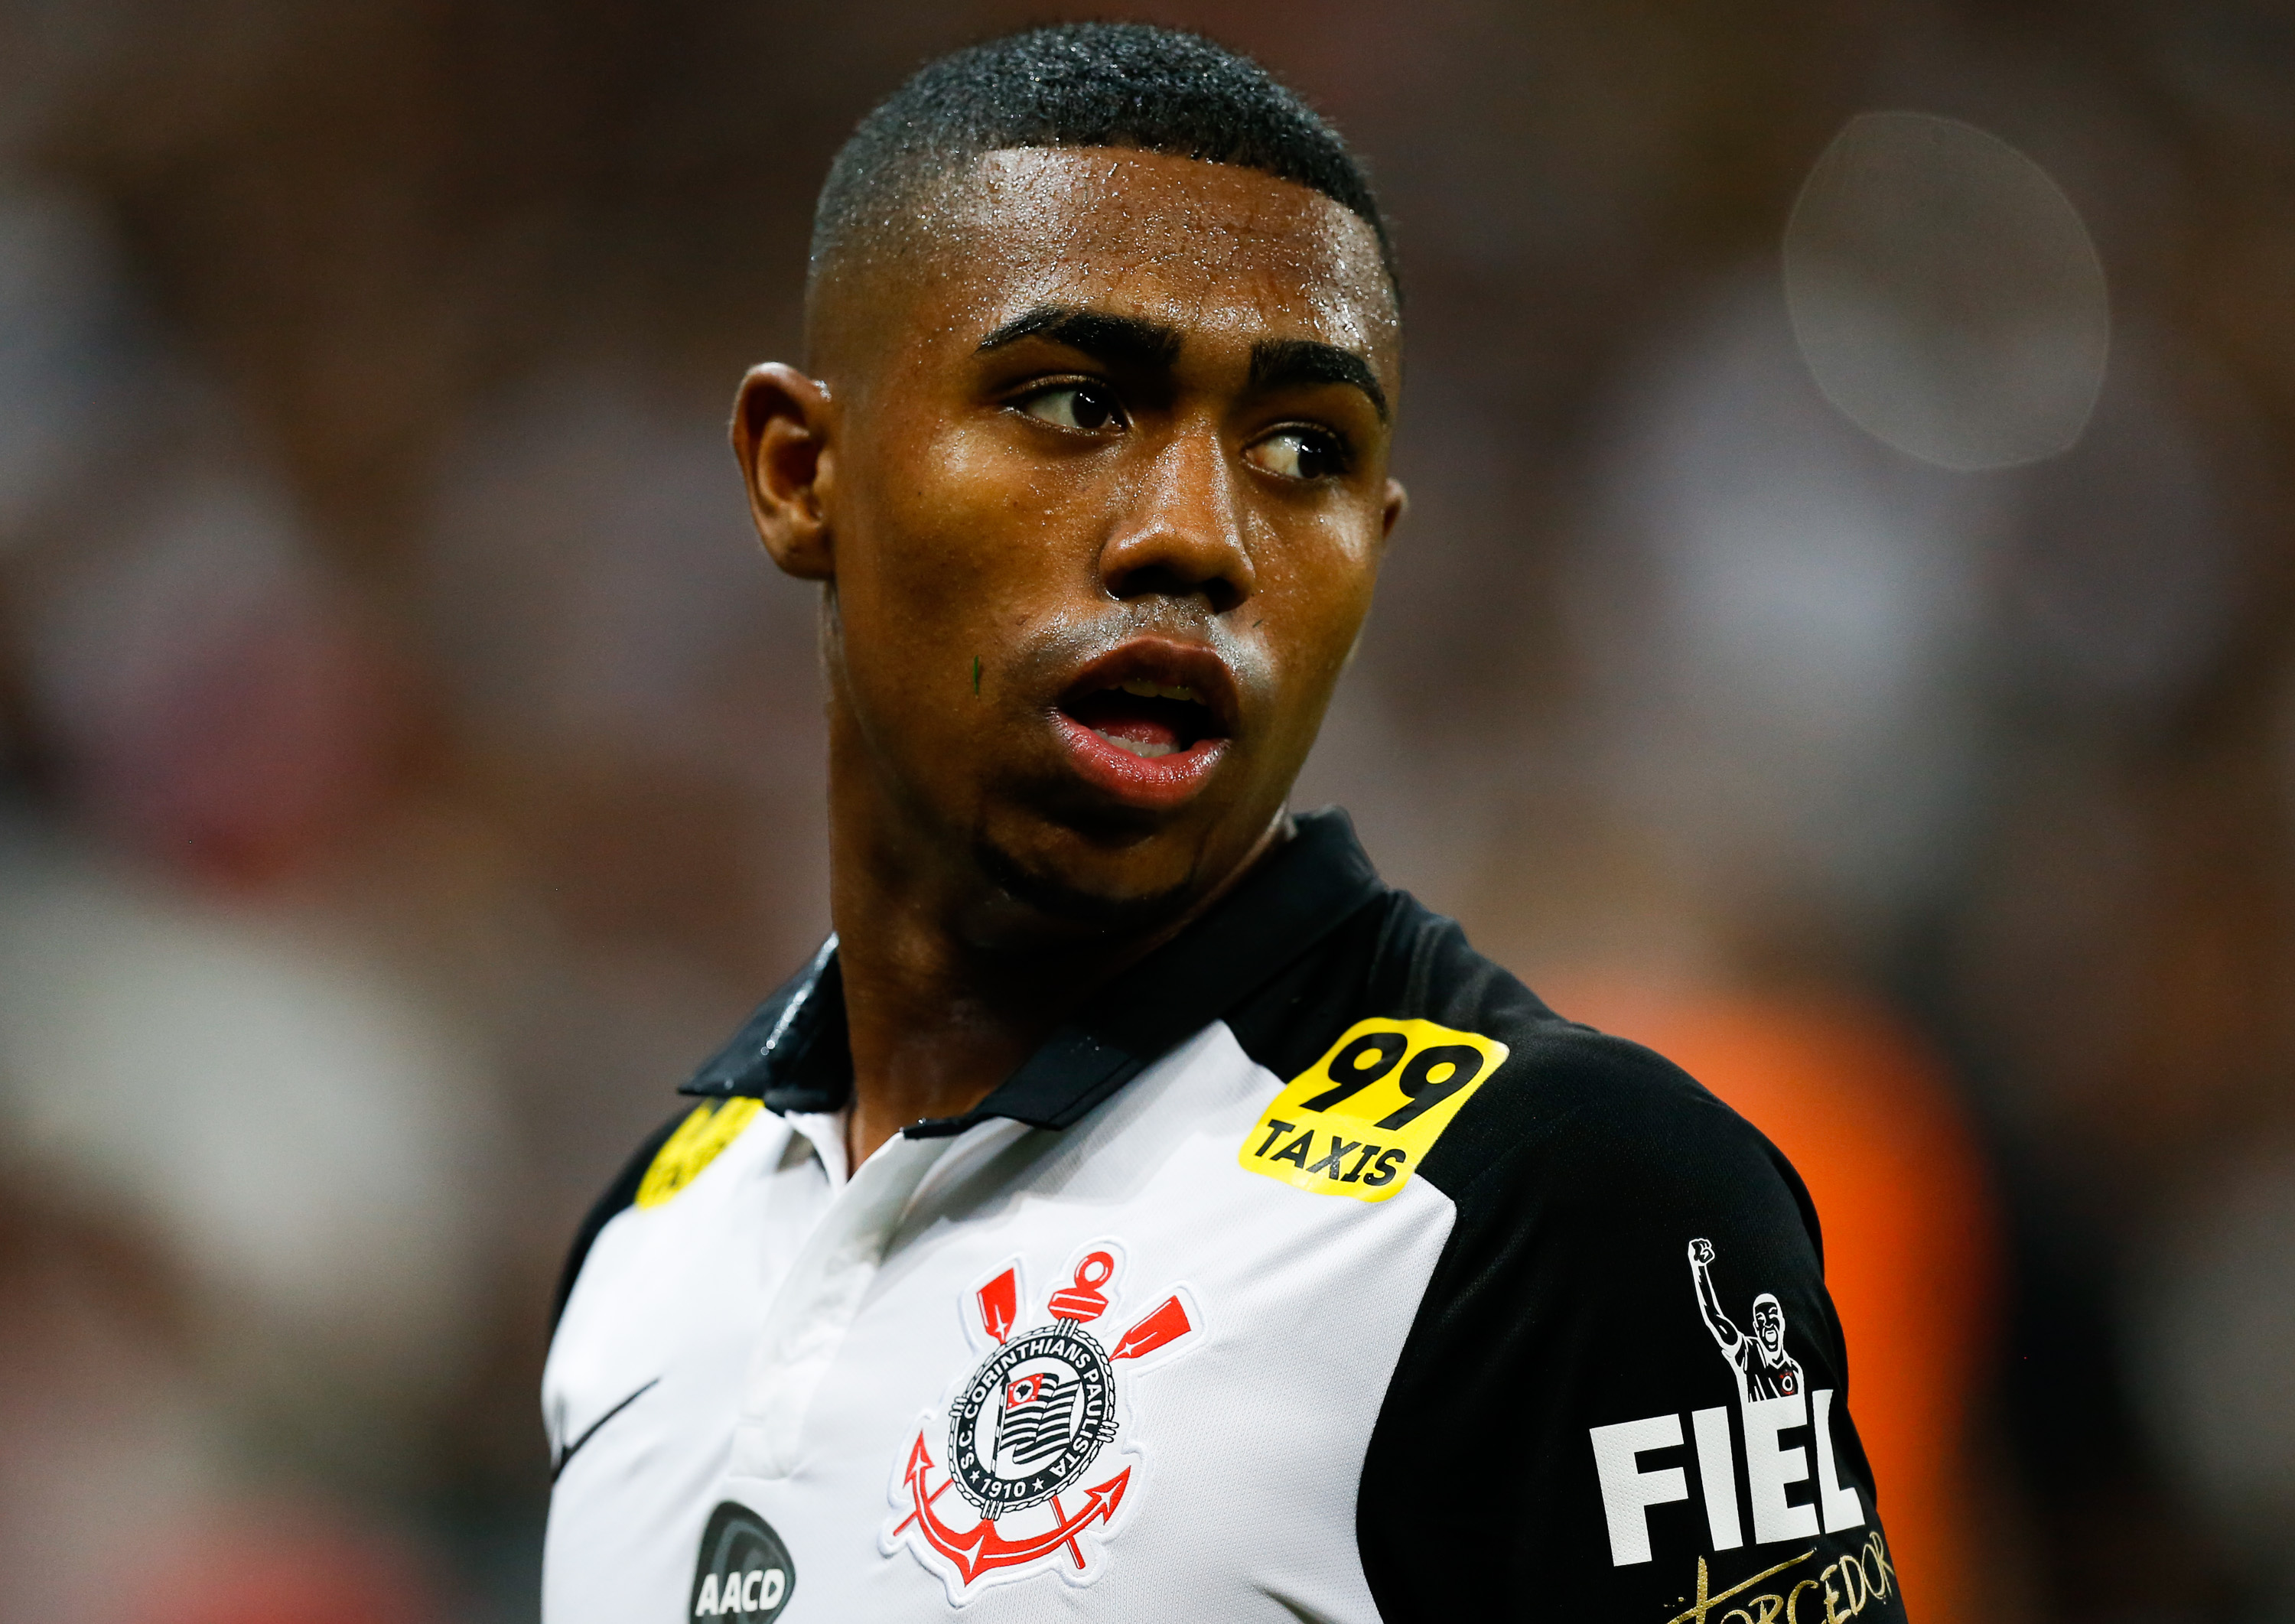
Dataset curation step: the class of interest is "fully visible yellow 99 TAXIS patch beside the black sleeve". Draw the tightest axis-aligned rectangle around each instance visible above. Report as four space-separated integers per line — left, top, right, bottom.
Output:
1235 1018 1508 1202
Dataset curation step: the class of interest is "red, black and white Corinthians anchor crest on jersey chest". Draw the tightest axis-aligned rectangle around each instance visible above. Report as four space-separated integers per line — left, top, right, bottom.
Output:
884 1241 1198 1601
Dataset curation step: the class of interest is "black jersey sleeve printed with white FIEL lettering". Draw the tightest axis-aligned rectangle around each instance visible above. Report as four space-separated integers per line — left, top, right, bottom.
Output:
1356 1023 1905 1624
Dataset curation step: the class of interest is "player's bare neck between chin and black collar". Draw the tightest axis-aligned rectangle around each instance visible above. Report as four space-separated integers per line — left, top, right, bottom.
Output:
828 771 1287 1167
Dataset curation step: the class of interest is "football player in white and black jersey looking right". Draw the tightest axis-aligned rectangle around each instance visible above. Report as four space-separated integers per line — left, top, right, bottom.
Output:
544 25 1903 1624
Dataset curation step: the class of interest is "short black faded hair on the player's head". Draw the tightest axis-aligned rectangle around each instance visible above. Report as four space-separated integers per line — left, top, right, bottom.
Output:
812 23 1402 296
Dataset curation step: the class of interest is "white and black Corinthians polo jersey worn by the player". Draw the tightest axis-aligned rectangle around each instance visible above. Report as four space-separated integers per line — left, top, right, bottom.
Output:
544 816 1898 1624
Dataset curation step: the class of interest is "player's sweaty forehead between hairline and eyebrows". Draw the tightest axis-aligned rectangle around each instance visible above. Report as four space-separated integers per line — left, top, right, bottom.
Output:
913 147 1400 369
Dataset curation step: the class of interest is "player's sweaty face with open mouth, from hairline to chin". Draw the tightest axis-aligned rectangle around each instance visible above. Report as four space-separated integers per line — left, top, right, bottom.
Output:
753 149 1402 917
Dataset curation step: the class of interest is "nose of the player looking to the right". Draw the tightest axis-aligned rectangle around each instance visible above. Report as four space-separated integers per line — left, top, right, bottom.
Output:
1099 427 1258 615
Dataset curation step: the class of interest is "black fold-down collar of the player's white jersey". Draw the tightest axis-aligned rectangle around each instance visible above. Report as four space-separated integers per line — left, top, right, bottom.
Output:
682 808 1386 1137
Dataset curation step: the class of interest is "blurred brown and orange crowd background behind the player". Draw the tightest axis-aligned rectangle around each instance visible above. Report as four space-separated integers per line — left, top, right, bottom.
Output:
0 0 2295 1624
